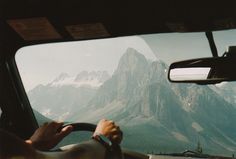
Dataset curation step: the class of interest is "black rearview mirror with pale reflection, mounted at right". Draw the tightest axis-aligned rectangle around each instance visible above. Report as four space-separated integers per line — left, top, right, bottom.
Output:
168 47 236 84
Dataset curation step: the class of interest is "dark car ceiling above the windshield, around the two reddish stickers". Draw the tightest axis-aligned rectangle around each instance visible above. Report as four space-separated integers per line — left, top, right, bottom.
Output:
0 0 236 59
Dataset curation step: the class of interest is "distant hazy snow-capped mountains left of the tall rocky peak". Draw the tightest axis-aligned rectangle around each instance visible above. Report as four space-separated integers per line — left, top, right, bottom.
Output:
28 71 109 120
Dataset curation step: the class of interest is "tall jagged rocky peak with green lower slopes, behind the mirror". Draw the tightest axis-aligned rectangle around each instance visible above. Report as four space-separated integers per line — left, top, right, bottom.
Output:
71 49 236 155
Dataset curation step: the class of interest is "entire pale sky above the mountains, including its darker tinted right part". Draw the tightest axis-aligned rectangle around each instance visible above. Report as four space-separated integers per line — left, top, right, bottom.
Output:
16 30 236 91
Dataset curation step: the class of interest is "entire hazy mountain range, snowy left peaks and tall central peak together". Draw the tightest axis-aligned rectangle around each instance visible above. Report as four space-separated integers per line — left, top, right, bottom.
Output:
28 48 236 155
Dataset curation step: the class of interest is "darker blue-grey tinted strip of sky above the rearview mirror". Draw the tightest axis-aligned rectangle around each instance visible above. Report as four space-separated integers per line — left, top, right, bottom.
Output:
141 29 236 64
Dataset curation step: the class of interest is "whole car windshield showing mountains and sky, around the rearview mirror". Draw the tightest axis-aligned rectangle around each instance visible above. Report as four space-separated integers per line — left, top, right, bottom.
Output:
16 30 236 156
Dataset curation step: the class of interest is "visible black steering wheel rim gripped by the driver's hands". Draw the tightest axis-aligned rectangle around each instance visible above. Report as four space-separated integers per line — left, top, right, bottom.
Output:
62 123 123 159
